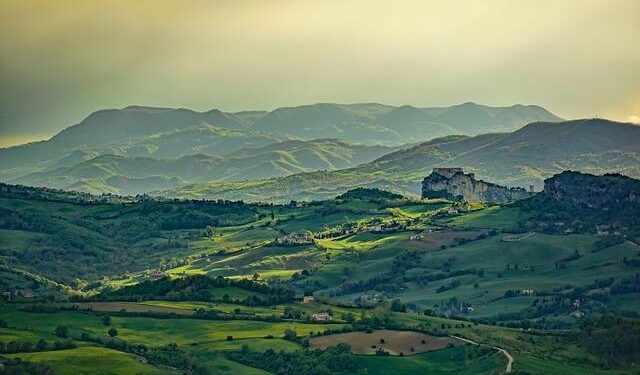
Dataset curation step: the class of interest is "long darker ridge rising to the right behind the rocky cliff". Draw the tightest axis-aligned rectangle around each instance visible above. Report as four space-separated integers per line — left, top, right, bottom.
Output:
158 119 640 201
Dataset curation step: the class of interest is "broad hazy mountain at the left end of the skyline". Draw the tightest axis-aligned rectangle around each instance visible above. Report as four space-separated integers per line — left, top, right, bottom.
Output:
0 106 291 180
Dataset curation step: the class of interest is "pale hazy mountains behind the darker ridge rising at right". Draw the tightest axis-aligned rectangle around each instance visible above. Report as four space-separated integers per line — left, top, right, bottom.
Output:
0 103 561 194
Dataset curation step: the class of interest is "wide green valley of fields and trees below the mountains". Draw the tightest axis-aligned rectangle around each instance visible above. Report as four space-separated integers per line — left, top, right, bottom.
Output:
0 175 640 374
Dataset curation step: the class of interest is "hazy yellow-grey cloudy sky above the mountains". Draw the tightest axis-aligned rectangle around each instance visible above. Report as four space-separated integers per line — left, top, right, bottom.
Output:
0 0 640 146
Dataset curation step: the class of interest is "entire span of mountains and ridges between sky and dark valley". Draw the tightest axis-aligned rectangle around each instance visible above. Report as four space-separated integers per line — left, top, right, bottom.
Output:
0 103 640 201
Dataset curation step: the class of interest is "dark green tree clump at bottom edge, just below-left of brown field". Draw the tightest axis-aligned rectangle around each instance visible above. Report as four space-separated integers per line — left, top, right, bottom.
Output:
226 344 360 375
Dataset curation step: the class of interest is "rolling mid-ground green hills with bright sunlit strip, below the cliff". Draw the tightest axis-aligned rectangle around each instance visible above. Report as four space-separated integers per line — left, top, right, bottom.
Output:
0 174 640 324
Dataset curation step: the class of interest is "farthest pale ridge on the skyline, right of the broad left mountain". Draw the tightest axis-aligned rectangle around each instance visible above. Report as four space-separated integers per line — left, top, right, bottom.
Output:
253 103 562 144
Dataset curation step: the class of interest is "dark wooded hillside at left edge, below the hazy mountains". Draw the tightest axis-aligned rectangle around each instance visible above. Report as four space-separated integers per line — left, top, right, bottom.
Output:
0 185 270 285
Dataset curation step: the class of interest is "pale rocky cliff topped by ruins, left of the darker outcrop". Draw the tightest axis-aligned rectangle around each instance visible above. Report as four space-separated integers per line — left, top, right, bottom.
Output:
422 168 533 203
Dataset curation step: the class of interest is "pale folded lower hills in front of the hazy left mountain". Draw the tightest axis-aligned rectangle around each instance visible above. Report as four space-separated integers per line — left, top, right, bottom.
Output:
12 139 394 195
